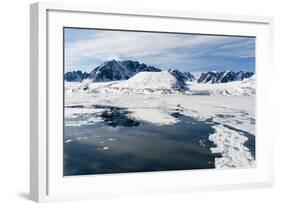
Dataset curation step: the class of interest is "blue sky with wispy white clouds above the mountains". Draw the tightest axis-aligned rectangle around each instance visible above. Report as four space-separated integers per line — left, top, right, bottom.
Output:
64 28 255 73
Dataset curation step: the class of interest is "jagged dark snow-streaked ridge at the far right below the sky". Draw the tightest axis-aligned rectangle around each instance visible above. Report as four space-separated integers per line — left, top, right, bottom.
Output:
197 70 254 83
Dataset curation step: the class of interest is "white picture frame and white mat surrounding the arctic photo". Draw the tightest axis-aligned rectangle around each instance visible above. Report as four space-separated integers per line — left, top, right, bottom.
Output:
30 2 273 202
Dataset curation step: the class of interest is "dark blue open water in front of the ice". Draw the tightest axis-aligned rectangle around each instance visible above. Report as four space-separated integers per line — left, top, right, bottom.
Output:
64 107 223 176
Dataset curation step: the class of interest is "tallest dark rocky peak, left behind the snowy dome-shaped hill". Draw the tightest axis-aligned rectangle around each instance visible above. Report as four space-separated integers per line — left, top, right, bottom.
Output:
89 60 161 82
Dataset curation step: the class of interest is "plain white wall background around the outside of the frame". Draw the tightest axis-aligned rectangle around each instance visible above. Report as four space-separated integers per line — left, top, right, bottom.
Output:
0 0 281 205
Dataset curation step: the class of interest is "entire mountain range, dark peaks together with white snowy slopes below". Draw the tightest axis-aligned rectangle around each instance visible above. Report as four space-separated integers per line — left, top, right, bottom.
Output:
64 60 256 95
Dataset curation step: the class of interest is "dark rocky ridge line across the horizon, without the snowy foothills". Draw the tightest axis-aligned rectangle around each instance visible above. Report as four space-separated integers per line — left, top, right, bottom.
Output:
64 59 254 84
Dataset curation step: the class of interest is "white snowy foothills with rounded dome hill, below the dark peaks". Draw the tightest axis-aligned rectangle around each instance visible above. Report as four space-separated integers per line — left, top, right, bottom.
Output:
65 71 256 96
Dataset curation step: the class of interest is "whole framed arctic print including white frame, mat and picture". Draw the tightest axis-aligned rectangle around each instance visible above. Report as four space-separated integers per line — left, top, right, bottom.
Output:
30 3 273 201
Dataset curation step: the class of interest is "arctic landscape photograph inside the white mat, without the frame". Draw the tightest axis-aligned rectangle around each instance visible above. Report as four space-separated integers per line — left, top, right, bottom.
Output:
62 27 256 176
